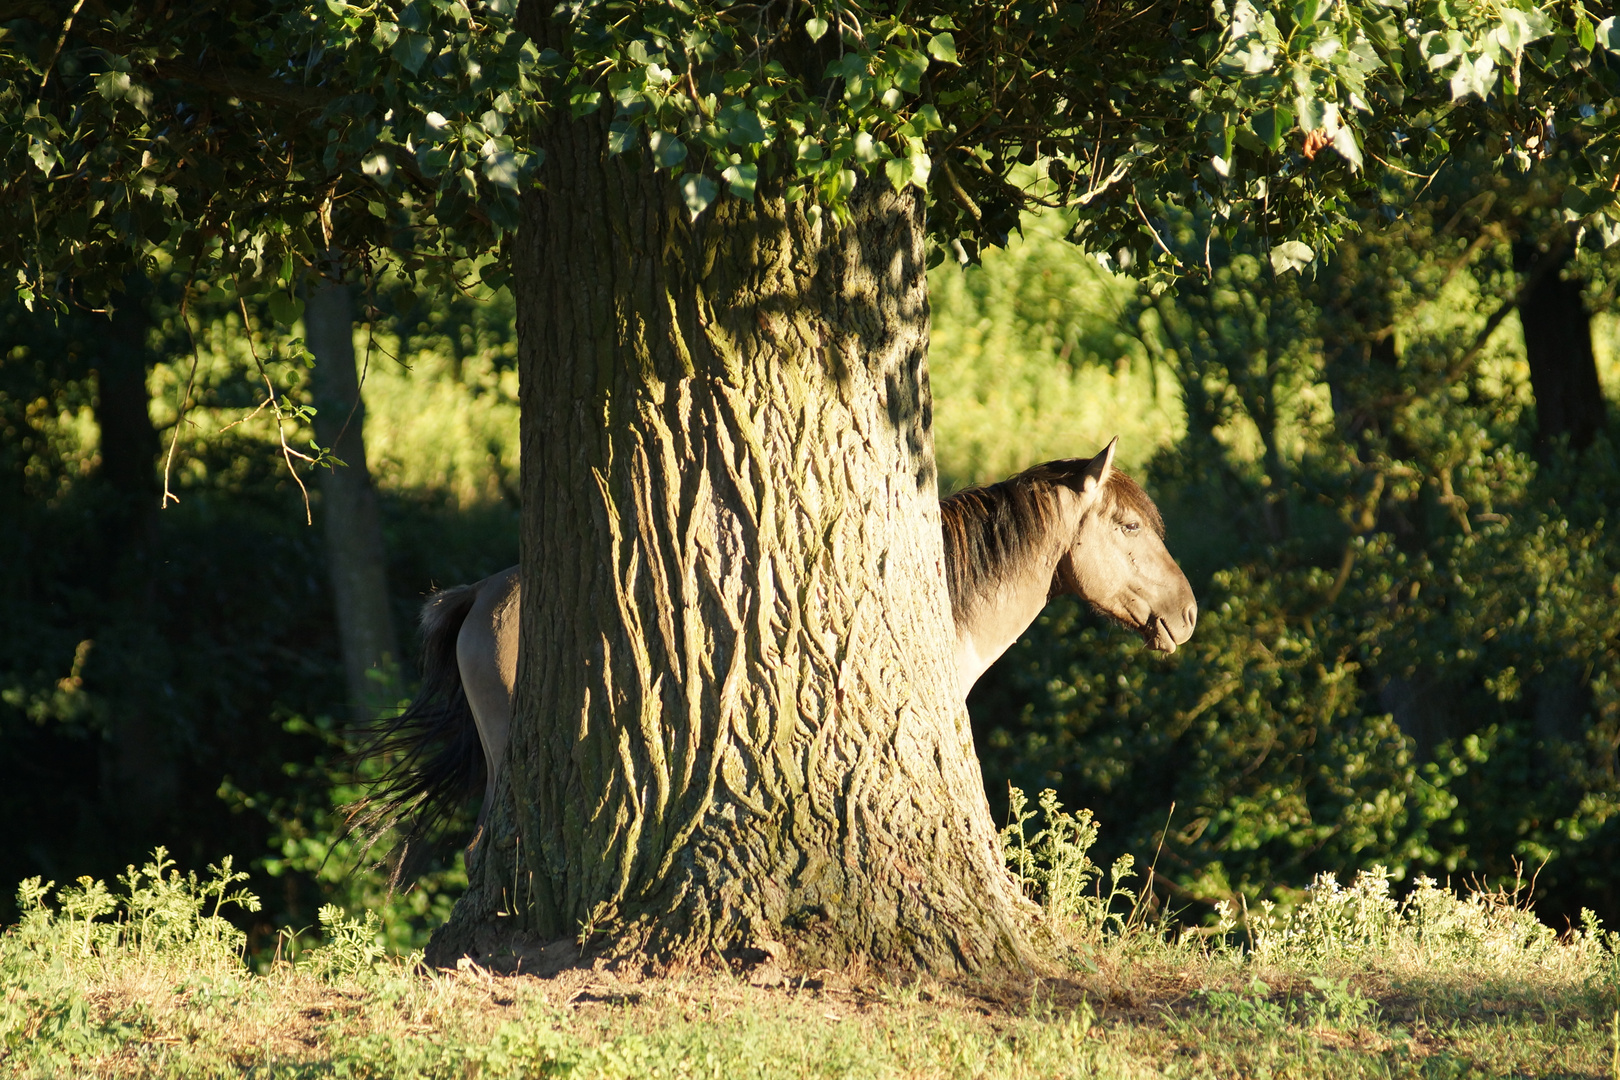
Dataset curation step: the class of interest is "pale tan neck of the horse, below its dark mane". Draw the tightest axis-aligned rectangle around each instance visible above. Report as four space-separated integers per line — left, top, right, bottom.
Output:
956 486 1081 698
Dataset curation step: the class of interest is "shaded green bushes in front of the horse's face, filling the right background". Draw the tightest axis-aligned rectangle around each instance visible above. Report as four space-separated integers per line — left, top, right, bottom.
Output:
970 173 1620 920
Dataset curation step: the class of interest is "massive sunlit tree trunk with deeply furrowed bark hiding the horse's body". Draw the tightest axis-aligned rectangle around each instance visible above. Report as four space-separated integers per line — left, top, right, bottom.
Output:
429 118 1030 972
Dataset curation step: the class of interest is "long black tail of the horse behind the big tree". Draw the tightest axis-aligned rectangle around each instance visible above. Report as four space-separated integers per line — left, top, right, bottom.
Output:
348 585 486 886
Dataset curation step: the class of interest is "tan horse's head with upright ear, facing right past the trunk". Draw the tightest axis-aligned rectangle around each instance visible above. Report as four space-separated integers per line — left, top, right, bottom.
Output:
1051 437 1199 653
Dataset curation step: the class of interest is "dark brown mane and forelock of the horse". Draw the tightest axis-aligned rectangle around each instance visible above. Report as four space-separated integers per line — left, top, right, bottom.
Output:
940 458 1165 625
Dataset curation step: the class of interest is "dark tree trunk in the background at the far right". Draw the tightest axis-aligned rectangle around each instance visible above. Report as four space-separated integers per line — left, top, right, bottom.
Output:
1513 241 1604 460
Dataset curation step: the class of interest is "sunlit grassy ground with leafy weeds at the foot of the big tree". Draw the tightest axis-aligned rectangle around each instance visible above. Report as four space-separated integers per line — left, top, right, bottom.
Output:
9 793 1620 1080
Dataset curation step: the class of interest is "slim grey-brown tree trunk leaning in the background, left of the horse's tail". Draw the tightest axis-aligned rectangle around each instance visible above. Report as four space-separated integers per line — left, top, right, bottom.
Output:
305 269 400 716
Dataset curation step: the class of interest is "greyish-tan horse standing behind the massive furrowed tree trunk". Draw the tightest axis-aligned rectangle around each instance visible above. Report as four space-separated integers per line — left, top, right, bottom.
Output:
352 437 1199 878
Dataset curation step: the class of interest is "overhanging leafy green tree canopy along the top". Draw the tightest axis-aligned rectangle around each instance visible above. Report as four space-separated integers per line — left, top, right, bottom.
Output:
0 0 1620 307
